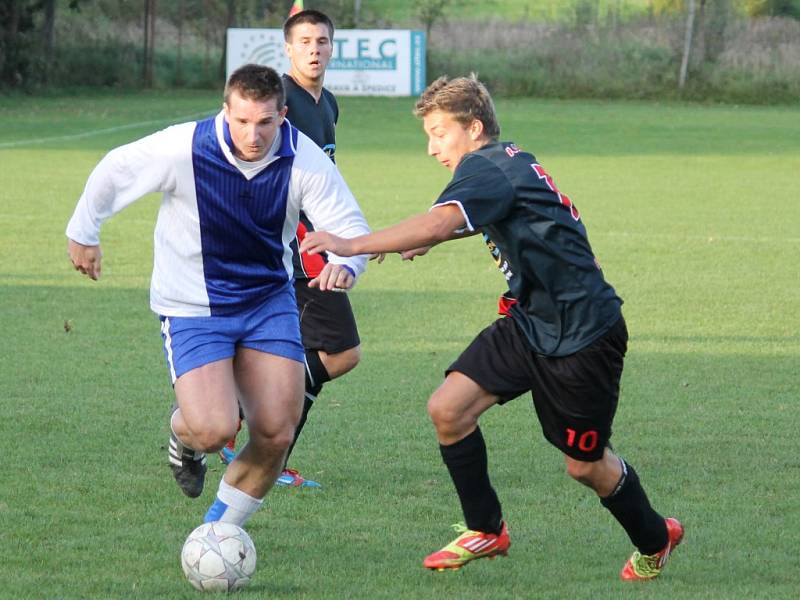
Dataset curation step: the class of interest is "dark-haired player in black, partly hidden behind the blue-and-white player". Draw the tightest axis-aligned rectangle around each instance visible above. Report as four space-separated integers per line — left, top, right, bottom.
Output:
220 10 361 487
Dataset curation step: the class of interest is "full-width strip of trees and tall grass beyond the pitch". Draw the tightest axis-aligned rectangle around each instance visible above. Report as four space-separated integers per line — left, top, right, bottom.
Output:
0 0 800 103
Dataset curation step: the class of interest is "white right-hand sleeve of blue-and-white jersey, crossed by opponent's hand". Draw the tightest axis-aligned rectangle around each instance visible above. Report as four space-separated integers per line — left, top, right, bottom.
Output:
289 133 370 276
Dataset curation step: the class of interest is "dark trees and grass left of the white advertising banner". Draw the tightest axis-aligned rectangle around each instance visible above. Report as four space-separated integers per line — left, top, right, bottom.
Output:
0 0 286 89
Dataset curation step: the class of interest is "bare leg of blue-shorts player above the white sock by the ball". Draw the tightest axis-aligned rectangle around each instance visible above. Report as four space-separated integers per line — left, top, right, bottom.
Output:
225 348 305 498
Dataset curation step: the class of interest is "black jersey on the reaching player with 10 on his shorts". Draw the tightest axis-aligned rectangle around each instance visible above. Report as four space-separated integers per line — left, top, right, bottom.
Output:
434 142 622 356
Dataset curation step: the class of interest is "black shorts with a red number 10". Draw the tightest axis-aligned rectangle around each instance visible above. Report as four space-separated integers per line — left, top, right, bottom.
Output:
447 317 628 461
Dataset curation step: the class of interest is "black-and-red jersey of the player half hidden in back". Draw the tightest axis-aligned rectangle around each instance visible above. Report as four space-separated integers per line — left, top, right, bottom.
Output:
282 73 339 279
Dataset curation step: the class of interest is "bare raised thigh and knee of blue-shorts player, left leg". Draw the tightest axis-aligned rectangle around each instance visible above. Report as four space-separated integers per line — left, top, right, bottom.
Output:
172 359 239 452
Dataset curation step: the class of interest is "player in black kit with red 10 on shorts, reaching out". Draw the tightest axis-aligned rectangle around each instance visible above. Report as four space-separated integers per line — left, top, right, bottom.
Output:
301 77 683 580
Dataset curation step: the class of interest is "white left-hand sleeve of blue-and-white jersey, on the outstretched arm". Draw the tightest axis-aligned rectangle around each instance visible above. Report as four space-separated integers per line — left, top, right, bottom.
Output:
66 123 195 246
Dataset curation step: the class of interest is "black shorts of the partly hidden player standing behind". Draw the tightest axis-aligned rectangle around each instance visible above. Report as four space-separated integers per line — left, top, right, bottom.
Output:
294 279 361 354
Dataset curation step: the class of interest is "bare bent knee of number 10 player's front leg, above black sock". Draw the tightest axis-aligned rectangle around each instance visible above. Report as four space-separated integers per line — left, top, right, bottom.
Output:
428 371 497 446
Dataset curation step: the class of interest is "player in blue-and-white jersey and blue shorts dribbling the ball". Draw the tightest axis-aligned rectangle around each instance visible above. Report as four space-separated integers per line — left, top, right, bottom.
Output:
66 65 369 525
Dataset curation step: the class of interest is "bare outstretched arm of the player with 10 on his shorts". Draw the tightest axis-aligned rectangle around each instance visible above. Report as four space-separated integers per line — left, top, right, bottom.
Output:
301 205 466 256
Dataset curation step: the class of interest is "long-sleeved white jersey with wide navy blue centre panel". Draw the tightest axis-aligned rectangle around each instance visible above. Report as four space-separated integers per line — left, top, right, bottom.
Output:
66 113 369 317
